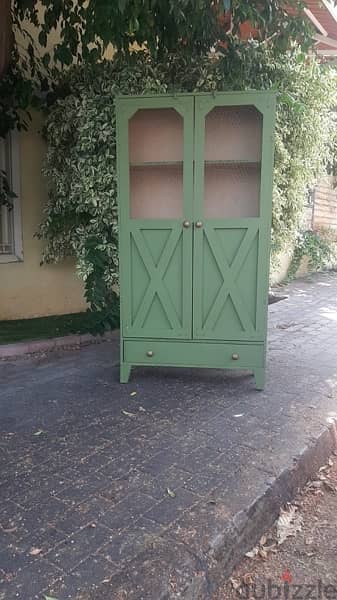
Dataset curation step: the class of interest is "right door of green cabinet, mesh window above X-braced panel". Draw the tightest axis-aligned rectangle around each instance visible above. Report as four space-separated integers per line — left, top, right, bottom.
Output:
193 93 275 340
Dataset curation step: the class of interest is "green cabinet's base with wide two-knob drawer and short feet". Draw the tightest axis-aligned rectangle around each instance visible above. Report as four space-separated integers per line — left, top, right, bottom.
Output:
120 339 265 390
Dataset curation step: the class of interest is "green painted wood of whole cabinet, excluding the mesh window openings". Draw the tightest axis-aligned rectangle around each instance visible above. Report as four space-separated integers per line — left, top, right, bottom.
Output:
116 92 275 389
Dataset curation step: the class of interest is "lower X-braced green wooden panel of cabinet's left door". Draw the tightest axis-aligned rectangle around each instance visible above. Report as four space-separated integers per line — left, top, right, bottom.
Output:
123 221 192 338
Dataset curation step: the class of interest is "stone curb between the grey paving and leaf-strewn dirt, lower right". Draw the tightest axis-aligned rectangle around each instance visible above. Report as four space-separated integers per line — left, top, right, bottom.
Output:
188 421 337 600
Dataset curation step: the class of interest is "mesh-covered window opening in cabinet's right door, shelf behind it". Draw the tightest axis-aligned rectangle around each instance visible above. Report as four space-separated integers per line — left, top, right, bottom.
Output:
203 106 262 219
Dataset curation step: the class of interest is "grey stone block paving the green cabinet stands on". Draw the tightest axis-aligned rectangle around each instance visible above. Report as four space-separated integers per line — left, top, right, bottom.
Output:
0 273 337 600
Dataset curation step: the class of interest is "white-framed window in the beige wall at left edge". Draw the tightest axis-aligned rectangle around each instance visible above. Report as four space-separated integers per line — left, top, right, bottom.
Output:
0 132 23 263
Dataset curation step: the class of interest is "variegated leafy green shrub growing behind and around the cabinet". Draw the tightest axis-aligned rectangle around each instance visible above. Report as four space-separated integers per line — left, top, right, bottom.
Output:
39 41 337 324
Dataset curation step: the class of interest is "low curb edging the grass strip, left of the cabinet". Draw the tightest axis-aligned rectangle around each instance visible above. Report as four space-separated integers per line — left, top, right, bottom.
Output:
0 329 119 360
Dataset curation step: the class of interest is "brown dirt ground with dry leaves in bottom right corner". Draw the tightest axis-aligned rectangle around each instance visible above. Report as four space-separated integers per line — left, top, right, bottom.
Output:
214 453 337 600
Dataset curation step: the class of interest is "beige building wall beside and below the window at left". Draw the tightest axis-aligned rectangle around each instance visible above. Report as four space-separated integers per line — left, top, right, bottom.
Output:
0 115 86 320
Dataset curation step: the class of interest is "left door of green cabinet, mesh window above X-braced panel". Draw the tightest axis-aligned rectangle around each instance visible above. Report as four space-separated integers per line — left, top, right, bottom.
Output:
117 95 194 339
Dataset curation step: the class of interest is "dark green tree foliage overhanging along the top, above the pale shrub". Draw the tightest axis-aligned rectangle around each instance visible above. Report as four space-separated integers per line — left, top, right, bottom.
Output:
0 0 311 210
